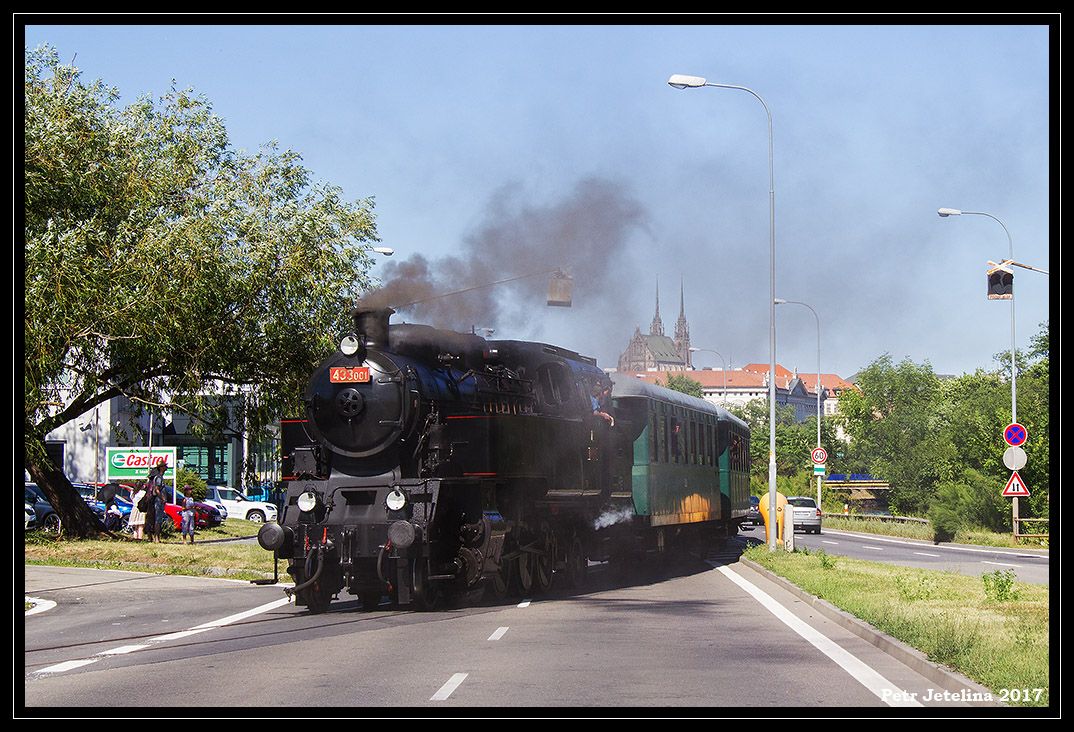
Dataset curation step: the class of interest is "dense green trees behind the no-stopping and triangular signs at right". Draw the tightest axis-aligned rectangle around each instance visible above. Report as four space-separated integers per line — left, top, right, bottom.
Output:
839 323 1050 519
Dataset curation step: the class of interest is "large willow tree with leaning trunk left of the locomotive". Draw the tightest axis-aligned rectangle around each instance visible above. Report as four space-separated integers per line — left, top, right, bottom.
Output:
24 47 378 536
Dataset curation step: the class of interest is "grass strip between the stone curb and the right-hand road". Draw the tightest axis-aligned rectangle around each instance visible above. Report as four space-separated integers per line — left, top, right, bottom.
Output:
743 546 1048 706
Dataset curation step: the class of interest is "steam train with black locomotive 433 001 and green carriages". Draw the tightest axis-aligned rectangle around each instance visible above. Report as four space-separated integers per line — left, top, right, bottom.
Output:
258 308 750 613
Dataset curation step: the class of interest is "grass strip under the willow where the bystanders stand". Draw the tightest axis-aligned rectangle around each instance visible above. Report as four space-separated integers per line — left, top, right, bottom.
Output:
25 518 287 580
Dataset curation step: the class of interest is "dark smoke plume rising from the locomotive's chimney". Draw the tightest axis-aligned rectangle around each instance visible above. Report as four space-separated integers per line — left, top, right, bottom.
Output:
360 178 648 339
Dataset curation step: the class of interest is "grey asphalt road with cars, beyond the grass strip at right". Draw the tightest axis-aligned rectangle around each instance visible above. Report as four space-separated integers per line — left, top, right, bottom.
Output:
744 526 1049 585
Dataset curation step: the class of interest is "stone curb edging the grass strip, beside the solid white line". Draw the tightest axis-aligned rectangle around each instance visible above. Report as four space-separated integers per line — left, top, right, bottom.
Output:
739 557 1005 706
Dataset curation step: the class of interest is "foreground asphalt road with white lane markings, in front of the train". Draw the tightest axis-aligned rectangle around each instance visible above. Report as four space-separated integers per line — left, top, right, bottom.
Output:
23 547 996 718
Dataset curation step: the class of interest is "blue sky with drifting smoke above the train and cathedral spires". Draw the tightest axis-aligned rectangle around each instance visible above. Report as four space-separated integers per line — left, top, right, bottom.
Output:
25 16 1058 377
